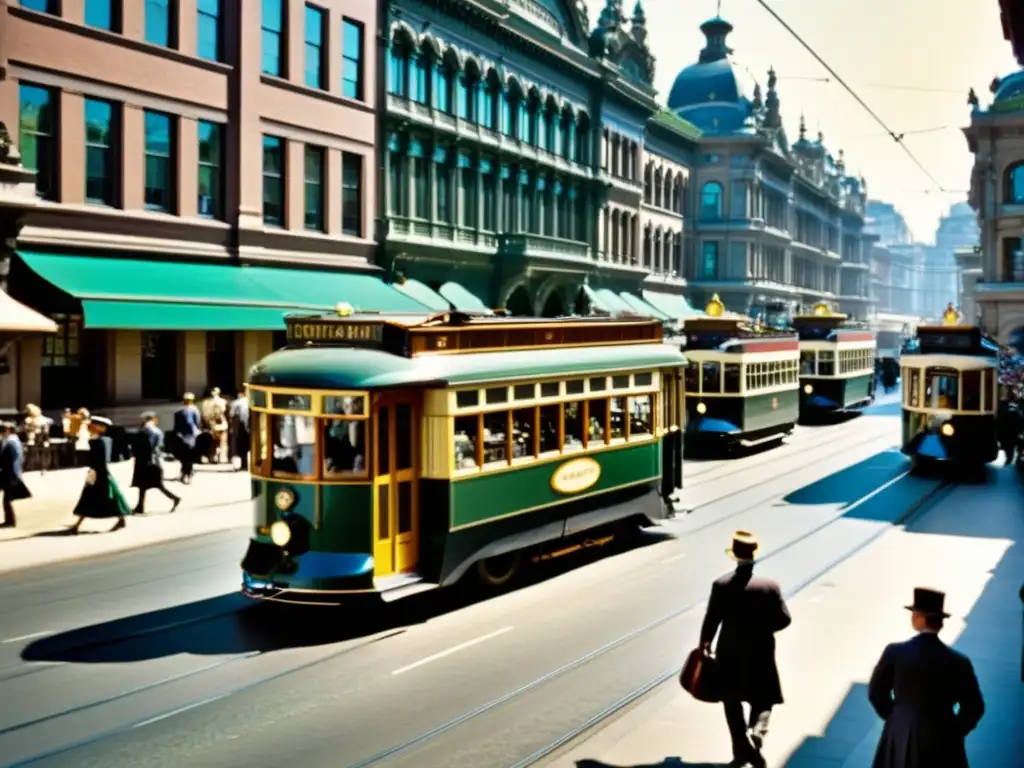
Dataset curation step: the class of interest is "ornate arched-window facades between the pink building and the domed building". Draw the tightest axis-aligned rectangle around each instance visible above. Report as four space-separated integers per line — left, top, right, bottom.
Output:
380 0 697 316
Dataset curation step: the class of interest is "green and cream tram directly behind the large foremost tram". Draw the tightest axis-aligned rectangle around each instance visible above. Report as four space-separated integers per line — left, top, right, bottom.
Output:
682 294 800 451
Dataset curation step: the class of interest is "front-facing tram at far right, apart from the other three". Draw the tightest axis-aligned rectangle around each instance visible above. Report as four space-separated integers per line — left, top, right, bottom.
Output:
900 304 999 464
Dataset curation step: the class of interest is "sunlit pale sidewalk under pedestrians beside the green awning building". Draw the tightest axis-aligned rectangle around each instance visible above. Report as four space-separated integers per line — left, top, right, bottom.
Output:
0 461 252 573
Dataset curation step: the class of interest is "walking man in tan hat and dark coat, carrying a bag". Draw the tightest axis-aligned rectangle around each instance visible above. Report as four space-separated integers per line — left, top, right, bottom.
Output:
700 530 793 766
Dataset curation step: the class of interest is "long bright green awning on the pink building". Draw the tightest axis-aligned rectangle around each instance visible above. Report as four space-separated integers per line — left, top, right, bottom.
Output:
18 251 432 331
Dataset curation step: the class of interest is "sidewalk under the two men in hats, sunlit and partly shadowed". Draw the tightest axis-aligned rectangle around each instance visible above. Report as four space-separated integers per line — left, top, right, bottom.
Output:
547 469 1024 768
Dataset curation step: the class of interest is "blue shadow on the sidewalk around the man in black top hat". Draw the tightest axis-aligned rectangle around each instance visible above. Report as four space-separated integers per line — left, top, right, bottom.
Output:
778 495 1024 768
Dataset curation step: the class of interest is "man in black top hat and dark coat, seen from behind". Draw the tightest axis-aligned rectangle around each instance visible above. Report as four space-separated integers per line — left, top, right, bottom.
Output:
867 588 985 768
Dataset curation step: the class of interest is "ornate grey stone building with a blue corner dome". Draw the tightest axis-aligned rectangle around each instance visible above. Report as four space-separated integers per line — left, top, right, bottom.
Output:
668 18 869 322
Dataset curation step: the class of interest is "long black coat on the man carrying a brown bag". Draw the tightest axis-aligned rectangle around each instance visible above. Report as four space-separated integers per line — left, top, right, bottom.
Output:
700 566 793 707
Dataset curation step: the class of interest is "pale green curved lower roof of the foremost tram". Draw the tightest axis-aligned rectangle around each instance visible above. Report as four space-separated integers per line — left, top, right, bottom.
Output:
249 341 686 390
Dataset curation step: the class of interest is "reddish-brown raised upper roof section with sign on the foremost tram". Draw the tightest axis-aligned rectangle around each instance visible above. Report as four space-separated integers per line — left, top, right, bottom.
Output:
286 305 663 357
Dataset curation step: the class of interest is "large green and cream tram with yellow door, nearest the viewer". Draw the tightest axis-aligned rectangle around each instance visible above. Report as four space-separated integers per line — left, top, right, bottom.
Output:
242 305 685 604
